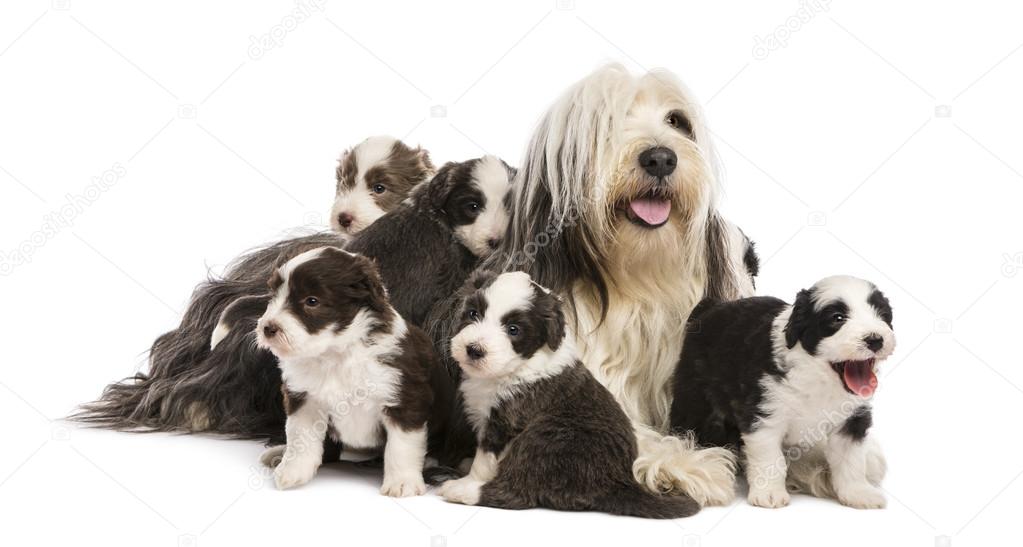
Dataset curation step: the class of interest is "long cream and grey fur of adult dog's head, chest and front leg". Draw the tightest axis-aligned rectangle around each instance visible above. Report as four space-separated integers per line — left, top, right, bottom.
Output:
478 65 756 504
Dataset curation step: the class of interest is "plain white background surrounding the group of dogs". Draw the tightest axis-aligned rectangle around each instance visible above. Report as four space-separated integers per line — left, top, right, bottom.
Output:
0 0 1023 547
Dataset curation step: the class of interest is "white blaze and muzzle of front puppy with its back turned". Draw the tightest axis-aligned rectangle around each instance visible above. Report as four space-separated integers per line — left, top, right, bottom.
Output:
451 272 533 377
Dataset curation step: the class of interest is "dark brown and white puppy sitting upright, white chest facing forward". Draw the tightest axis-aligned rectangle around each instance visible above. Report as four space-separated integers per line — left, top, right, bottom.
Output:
256 247 448 496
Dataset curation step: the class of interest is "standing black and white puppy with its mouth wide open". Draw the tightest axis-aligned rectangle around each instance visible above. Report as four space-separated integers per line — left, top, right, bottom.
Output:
671 276 895 508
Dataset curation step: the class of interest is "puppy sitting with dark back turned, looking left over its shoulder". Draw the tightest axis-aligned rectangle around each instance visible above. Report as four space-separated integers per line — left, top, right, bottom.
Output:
440 272 700 518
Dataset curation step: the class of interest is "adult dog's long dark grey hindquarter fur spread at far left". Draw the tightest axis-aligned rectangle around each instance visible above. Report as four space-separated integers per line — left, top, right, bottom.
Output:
71 233 339 440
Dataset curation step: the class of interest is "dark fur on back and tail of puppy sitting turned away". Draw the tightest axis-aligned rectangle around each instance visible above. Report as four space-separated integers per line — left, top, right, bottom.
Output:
472 362 700 518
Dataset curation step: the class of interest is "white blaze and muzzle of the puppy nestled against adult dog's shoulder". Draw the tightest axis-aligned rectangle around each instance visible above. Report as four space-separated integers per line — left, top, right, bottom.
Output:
454 155 510 257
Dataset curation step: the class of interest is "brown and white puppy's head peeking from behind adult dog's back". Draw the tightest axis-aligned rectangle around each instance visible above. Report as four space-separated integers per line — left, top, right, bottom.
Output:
330 135 434 236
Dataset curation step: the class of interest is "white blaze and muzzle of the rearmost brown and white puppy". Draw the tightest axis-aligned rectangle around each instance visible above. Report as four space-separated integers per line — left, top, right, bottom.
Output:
330 136 396 235
